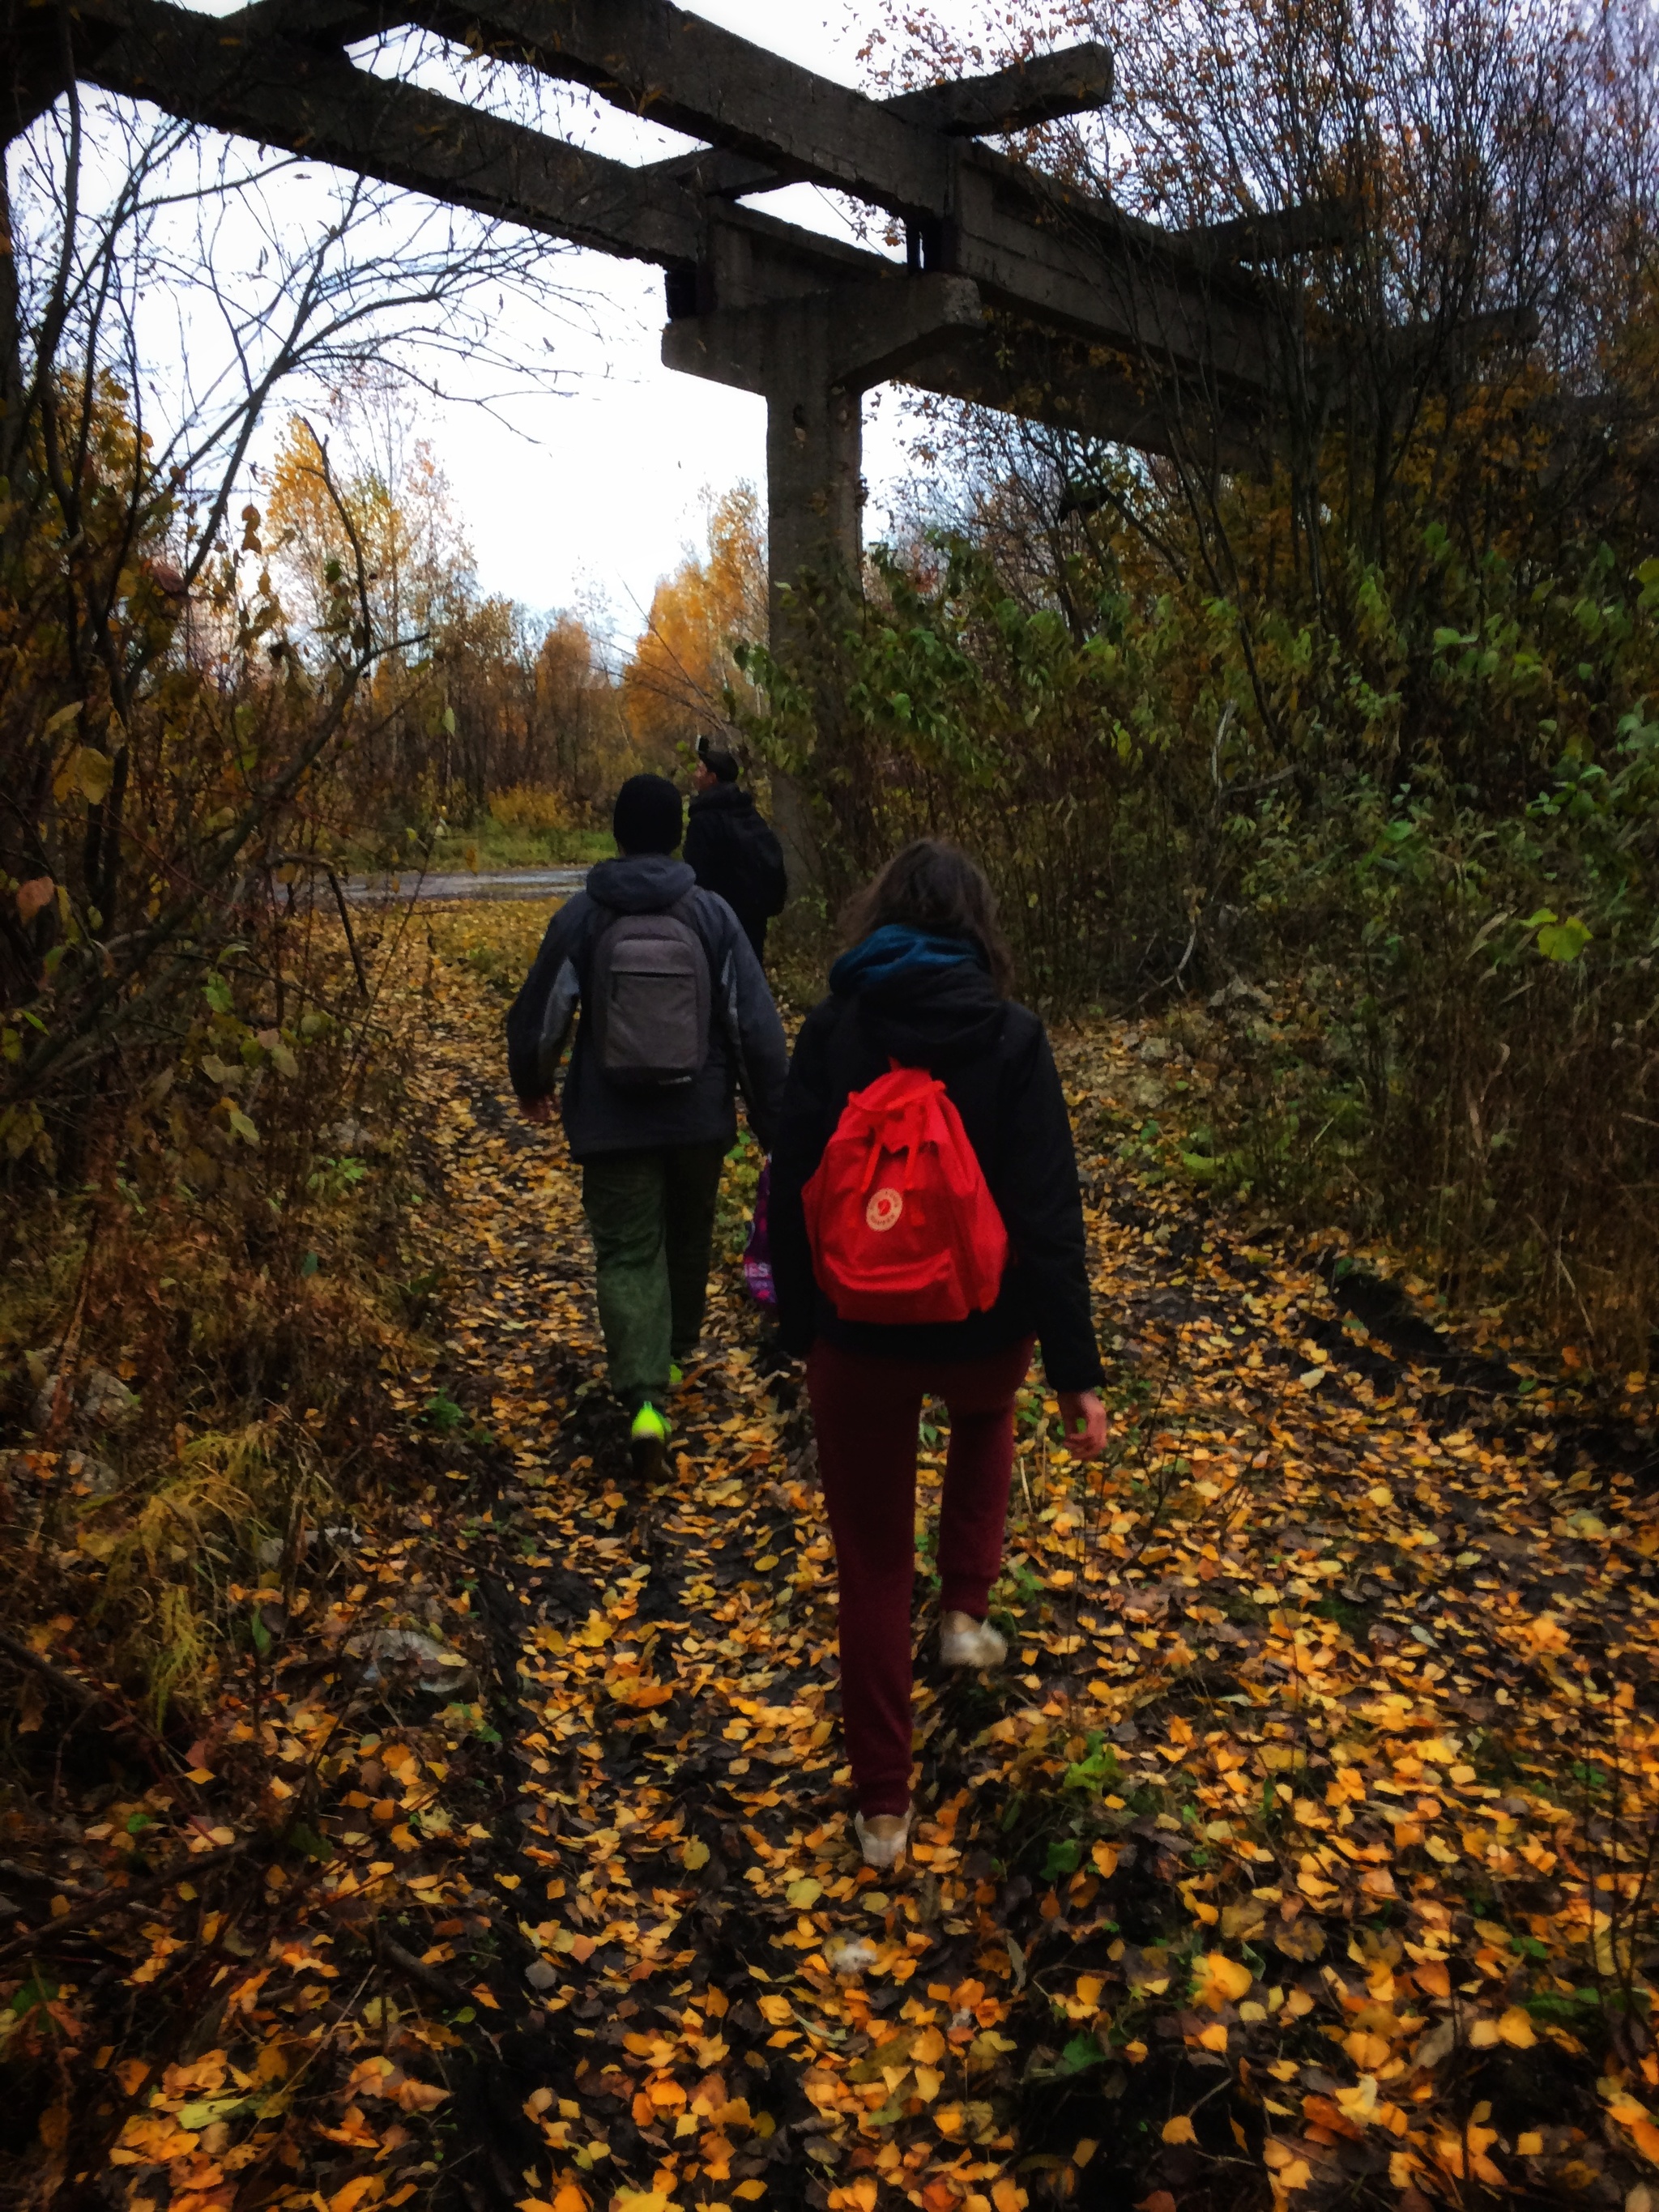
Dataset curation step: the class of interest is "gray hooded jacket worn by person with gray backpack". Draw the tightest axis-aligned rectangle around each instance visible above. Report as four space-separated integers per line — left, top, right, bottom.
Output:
506 851 790 1161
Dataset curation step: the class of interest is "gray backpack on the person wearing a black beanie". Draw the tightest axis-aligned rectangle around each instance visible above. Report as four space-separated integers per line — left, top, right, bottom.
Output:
588 892 712 1090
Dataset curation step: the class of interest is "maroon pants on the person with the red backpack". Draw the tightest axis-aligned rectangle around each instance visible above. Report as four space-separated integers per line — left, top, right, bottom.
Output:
808 1338 1030 1816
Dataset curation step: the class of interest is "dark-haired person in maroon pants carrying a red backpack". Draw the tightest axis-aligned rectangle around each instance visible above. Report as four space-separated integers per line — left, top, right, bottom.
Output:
770 838 1106 1867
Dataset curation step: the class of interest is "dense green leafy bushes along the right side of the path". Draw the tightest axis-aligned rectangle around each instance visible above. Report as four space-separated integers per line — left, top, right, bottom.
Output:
750 522 1659 1365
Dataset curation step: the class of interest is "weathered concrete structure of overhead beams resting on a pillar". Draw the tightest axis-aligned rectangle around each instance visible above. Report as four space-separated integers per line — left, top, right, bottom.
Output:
0 0 1341 872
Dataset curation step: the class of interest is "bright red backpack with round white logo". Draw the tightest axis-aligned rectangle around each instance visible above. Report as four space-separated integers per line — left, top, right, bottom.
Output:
801 1064 1009 1323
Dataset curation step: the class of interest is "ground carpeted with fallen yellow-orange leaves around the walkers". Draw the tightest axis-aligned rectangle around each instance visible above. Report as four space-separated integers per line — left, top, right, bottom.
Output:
0 909 1659 2212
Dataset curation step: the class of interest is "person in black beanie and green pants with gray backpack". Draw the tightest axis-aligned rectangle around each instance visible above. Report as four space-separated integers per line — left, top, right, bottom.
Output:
506 777 787 1480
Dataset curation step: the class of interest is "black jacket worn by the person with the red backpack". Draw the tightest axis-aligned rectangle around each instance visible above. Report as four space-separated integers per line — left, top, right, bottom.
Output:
770 962 1102 1392
